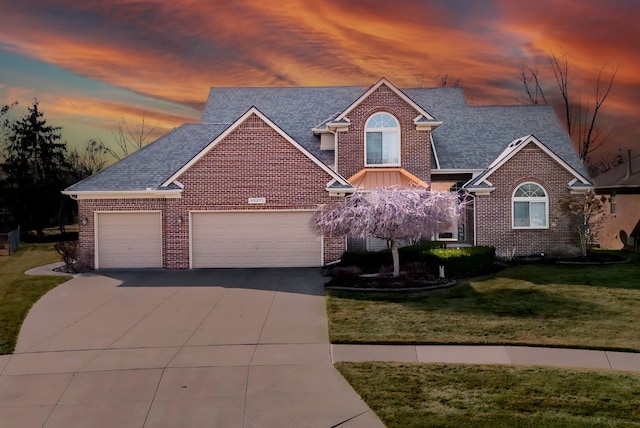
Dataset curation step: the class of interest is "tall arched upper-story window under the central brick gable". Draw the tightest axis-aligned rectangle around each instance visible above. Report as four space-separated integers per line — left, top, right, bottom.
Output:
364 112 400 166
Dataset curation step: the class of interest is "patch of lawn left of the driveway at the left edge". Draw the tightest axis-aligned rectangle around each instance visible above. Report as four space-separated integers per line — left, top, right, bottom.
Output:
0 244 69 355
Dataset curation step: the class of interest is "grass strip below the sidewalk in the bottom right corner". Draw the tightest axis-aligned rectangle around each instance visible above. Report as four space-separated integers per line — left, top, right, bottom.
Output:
336 363 640 428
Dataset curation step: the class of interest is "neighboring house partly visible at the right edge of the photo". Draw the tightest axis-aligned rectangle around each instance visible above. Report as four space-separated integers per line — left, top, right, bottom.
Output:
593 150 640 251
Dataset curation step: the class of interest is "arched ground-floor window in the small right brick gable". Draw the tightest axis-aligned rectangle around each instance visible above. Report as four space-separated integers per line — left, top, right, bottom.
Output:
512 183 549 229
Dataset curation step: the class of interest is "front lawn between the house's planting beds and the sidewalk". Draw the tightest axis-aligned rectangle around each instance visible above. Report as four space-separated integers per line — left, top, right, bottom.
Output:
327 251 640 351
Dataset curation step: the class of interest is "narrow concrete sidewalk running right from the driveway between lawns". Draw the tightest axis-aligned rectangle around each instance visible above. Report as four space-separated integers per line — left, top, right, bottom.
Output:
331 345 640 371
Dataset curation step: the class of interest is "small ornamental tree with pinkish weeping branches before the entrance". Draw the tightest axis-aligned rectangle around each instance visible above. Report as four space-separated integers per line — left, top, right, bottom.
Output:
315 187 462 277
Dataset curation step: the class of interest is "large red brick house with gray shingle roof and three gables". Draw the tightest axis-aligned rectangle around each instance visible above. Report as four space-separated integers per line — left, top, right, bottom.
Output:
63 78 593 269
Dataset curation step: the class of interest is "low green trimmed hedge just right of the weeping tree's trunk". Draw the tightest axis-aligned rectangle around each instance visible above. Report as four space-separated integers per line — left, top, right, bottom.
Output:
423 246 496 277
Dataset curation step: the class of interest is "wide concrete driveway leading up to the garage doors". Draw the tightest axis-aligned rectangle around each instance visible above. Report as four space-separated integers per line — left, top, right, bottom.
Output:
0 269 382 428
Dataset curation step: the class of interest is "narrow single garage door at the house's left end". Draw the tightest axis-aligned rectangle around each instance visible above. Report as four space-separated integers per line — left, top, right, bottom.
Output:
96 212 162 268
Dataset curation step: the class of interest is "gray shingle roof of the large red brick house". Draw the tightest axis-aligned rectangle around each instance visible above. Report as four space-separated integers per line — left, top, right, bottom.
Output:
67 82 588 192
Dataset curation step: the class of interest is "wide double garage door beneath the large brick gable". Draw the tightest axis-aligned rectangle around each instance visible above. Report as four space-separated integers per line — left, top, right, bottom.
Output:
191 211 322 268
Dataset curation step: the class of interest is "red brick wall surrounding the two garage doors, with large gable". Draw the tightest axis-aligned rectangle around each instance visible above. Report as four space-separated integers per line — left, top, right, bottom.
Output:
78 115 344 269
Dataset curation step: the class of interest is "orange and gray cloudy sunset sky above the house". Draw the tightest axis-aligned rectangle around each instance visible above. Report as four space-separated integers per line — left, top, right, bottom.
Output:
0 0 640 164
